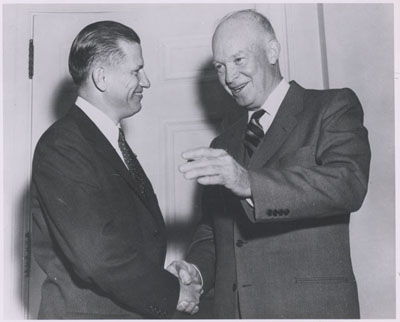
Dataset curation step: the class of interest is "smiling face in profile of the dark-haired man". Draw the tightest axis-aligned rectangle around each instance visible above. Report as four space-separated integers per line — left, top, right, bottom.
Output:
104 41 150 122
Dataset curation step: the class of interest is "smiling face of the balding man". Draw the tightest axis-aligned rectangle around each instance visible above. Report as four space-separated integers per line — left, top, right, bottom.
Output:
213 19 281 110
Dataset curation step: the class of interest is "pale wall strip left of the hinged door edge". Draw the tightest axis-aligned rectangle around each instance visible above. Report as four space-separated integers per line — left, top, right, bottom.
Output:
0 7 31 319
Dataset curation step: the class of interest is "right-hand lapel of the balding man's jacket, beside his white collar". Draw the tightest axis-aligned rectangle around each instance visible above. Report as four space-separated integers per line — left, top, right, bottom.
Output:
249 82 304 168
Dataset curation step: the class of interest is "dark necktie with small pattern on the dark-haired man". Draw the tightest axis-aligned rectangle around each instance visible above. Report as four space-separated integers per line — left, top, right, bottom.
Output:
118 129 153 198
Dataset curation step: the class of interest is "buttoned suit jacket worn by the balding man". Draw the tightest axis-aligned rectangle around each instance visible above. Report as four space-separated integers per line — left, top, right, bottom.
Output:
187 82 370 319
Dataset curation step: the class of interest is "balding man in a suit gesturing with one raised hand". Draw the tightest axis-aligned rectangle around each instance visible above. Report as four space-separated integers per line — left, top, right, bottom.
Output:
168 10 370 319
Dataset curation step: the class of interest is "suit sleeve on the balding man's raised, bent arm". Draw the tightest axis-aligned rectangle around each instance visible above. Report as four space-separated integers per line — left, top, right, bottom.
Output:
242 89 371 222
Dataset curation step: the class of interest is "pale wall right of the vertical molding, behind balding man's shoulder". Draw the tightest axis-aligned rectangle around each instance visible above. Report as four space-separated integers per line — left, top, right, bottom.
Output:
323 4 396 318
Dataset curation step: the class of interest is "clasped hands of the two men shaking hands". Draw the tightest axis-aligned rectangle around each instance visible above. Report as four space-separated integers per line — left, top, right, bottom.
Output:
167 260 204 314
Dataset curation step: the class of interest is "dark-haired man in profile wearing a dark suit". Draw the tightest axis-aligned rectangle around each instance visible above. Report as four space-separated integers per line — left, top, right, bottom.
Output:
32 21 201 319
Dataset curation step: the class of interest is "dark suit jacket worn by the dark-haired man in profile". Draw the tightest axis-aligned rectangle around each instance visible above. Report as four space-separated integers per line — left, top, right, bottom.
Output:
32 106 179 319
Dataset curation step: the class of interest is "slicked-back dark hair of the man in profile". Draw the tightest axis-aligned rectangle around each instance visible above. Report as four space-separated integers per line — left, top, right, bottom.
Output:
68 21 140 86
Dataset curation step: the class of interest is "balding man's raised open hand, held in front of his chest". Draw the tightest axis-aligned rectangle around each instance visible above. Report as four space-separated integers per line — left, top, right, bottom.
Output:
179 148 251 198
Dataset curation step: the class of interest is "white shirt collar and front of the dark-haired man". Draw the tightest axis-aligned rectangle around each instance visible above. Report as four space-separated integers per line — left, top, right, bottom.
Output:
75 96 120 150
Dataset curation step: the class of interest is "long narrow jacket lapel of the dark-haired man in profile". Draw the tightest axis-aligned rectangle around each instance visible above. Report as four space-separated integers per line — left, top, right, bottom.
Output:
70 106 162 221
